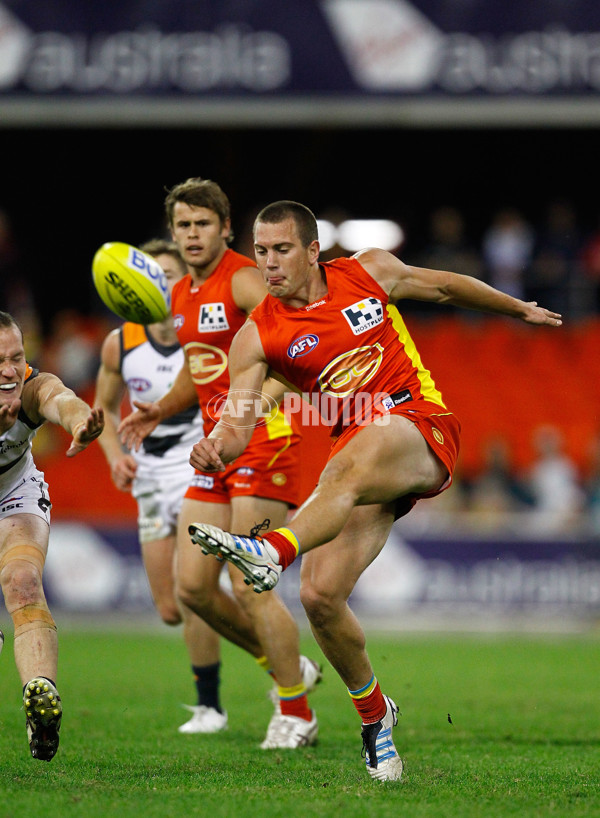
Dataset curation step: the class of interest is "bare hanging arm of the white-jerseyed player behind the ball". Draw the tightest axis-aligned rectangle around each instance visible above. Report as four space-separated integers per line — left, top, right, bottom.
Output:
95 330 137 491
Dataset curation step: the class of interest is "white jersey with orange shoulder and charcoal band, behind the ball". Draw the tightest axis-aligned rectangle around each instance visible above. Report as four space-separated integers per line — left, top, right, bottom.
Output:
119 323 203 477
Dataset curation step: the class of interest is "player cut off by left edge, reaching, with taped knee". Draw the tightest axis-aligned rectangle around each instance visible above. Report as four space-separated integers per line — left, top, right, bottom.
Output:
0 312 104 761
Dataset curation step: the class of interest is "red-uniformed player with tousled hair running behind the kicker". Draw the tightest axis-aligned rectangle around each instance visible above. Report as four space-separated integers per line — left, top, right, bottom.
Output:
120 178 321 749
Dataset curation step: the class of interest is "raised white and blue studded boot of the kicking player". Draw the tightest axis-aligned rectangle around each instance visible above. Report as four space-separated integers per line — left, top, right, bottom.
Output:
188 523 283 594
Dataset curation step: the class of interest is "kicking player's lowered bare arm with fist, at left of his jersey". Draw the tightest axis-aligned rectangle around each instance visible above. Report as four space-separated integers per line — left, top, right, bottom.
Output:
190 321 268 472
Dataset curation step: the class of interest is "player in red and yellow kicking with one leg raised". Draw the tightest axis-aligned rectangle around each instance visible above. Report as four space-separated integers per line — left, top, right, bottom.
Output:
184 202 561 781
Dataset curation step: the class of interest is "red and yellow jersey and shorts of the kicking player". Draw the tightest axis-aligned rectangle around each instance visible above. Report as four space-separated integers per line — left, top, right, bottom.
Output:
250 258 460 513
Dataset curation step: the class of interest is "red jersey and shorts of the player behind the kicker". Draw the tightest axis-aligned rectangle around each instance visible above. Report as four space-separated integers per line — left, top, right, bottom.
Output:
171 249 300 506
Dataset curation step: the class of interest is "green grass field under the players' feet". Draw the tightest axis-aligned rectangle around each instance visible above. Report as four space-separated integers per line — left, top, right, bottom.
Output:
0 623 600 818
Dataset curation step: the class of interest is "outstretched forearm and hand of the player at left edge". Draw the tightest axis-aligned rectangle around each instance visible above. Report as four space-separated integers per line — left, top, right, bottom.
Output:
24 372 104 457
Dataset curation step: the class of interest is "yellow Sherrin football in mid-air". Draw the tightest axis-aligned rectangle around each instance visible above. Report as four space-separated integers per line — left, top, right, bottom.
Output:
92 241 171 324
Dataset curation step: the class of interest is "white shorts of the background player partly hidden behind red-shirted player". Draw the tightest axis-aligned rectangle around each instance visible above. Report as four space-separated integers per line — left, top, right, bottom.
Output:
132 464 193 543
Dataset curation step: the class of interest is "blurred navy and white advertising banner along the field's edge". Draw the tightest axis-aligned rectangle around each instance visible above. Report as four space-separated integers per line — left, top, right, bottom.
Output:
36 522 600 630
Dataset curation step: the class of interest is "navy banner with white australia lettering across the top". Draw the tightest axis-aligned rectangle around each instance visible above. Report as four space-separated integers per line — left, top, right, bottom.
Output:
0 0 600 124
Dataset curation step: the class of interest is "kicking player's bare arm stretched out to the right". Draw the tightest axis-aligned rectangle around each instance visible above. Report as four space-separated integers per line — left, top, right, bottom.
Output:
355 249 562 327
